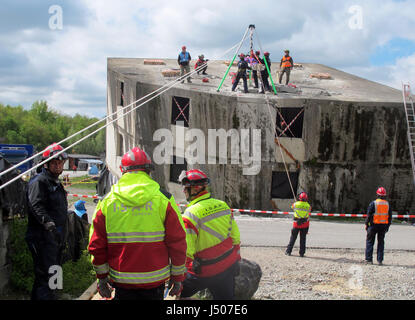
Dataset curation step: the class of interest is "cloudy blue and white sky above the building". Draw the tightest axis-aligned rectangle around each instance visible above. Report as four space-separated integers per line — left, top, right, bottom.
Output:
0 0 415 117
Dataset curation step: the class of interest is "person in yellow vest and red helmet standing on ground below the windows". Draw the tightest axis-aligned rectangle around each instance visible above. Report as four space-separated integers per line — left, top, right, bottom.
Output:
285 192 311 257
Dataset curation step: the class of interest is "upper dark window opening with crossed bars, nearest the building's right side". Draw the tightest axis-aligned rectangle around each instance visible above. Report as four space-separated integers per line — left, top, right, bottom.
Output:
277 108 304 138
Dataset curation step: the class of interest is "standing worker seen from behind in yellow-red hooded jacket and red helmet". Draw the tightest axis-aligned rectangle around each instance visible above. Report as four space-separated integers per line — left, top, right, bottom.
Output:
88 147 187 300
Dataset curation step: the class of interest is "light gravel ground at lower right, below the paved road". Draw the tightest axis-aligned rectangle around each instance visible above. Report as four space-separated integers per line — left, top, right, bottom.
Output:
241 244 415 300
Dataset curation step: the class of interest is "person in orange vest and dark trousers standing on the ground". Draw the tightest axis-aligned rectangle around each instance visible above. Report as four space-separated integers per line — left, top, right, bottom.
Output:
365 187 392 265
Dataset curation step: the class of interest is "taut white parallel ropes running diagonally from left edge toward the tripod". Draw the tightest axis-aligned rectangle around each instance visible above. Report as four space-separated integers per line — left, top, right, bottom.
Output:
0 39 247 190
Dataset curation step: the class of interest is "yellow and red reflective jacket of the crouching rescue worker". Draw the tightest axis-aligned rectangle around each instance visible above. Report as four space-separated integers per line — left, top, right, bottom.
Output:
183 193 240 277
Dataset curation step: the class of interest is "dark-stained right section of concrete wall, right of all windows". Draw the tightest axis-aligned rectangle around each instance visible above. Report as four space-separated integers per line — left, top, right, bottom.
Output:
301 100 415 213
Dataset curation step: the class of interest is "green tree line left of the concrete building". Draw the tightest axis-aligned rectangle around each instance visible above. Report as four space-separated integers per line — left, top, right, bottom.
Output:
0 101 105 156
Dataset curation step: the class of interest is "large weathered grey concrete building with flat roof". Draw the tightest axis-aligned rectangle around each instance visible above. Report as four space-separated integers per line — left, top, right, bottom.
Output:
106 58 415 213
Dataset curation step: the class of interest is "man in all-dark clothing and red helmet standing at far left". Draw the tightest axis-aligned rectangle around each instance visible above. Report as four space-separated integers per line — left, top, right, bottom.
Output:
25 143 68 300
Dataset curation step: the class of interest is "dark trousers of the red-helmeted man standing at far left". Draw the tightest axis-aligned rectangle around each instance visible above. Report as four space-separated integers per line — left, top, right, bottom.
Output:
26 232 62 300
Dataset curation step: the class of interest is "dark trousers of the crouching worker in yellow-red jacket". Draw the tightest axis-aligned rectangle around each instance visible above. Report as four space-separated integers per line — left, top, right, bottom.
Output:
181 262 239 300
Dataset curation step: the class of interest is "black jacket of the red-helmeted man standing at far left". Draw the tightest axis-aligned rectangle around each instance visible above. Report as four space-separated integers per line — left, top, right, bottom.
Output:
27 168 68 233
